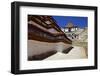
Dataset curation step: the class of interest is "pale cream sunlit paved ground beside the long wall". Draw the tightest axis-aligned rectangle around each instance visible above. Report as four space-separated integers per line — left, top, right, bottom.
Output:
45 46 87 60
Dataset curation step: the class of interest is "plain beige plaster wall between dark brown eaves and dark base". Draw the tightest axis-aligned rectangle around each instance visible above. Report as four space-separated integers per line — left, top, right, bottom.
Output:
28 40 71 56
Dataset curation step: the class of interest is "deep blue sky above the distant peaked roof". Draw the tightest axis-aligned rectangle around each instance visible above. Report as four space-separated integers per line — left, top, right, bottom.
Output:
52 16 88 28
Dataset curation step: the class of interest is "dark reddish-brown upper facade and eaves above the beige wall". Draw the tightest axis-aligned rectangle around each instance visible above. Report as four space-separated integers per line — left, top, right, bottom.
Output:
28 15 71 44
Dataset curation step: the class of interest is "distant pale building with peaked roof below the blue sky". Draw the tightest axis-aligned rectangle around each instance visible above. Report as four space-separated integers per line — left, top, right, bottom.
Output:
62 22 87 41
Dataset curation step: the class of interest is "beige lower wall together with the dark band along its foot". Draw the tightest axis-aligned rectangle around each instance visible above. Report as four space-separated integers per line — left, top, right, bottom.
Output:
28 40 71 61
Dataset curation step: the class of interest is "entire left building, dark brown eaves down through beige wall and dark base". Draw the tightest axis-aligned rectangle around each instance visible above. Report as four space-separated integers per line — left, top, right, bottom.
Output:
28 15 72 60
